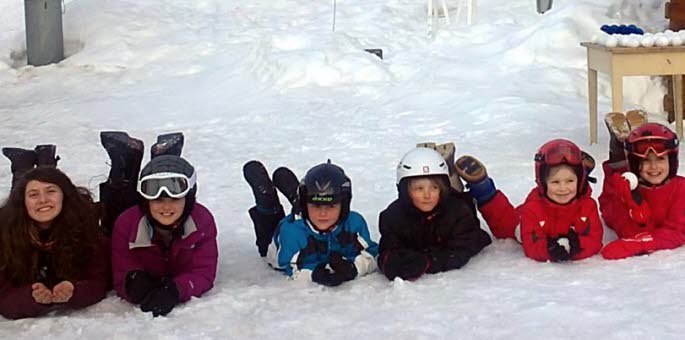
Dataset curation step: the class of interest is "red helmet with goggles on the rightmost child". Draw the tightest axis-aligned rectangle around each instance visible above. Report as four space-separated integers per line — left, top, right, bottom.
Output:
626 123 678 178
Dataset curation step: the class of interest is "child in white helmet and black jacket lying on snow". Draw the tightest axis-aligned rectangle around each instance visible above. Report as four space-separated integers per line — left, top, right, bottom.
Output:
378 148 491 280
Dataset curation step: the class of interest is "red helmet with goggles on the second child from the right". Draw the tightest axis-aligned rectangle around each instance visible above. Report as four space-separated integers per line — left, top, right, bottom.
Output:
535 139 594 195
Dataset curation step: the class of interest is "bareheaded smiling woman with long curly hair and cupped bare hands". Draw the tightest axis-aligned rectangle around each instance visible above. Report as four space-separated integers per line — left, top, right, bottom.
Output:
0 167 110 319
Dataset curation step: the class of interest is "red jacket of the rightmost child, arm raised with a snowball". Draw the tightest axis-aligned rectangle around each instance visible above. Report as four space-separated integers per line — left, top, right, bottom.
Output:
599 162 685 250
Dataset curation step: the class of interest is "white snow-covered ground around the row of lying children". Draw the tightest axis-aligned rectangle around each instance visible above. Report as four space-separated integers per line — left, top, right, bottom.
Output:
0 0 685 340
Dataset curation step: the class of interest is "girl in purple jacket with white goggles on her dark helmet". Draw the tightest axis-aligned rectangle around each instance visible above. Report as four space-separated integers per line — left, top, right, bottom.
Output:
112 154 217 316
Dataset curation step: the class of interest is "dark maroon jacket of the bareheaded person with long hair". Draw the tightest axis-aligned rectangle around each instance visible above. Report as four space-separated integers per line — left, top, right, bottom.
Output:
0 237 111 319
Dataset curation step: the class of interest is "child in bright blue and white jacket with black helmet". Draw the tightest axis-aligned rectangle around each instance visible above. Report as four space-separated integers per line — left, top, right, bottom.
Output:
243 161 378 286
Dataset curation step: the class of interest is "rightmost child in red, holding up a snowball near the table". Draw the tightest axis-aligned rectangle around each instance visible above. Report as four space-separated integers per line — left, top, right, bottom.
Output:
599 112 685 259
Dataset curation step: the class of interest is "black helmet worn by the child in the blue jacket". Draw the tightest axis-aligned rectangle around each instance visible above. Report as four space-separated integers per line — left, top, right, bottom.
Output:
298 159 352 223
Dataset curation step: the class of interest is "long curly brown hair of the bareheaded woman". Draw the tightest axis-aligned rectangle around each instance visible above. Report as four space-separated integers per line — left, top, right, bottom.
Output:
0 168 103 285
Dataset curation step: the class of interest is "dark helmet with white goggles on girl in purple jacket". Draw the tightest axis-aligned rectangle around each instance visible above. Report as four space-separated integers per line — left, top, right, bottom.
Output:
138 155 197 227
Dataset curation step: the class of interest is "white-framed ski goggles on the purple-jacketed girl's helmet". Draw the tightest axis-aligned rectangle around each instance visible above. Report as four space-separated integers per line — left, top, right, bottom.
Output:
138 172 197 200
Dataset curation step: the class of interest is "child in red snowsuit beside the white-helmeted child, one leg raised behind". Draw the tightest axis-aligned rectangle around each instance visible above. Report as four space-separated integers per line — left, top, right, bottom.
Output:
456 139 603 262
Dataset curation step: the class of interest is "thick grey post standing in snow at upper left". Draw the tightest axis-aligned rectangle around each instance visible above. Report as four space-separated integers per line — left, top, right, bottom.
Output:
24 0 64 66
